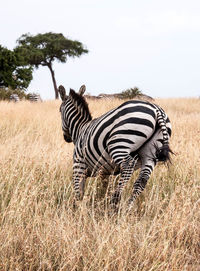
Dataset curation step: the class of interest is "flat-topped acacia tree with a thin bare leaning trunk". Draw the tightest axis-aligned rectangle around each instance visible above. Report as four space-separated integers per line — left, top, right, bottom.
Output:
15 32 88 99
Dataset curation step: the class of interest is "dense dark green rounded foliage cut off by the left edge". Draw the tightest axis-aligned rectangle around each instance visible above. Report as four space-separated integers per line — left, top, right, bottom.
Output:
0 45 32 89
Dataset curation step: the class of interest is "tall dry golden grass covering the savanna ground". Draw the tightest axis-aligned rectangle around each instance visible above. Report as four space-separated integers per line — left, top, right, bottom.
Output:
0 96 200 271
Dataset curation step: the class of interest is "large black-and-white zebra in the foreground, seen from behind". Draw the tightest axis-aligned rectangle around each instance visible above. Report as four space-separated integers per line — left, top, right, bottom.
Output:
58 85 171 208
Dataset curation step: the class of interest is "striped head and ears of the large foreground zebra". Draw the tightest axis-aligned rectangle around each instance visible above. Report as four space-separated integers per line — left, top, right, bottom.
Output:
58 85 86 143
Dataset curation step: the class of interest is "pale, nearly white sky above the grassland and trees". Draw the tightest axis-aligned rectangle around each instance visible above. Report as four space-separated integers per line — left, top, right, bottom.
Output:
0 0 200 99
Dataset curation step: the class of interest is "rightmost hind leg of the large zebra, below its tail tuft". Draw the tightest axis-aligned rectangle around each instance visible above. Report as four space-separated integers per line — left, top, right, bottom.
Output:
128 160 156 208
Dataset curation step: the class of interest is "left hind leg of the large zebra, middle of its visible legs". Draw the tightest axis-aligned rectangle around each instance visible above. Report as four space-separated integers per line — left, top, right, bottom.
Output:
110 155 138 207
